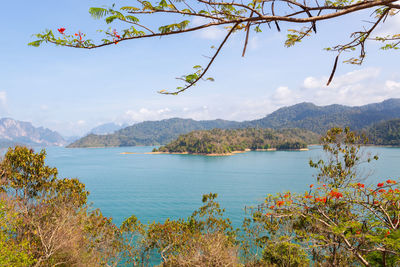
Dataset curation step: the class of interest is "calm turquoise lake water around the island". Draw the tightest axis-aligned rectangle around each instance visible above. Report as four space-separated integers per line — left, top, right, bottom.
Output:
43 146 400 226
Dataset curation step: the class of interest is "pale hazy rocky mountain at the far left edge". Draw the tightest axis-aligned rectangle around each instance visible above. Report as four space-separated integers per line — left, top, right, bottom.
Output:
0 118 66 147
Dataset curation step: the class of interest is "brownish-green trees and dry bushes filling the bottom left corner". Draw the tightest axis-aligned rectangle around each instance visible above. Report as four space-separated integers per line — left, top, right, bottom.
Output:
0 146 122 266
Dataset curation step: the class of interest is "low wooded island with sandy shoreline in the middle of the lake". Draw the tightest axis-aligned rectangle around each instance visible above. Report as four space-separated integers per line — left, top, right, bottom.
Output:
153 128 319 154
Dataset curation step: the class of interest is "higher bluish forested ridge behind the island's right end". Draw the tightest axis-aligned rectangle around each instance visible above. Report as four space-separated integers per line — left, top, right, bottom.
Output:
242 99 400 134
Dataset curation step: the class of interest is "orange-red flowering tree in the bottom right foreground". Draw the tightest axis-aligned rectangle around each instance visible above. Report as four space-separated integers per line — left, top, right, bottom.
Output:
245 128 400 266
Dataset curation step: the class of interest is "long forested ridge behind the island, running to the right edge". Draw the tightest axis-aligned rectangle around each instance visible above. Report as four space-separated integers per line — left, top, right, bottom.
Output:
68 99 400 147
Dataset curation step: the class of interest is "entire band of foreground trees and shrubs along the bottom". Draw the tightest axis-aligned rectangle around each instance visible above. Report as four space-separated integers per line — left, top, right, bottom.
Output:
0 128 400 267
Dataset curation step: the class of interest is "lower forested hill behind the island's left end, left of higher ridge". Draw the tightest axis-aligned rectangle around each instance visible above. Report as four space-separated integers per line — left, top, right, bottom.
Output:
67 118 240 147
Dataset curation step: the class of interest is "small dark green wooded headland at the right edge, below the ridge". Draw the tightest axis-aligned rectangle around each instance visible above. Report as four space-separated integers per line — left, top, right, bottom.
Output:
366 119 400 146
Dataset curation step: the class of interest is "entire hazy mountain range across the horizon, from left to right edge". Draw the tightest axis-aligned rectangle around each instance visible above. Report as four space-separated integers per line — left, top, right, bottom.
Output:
0 99 400 147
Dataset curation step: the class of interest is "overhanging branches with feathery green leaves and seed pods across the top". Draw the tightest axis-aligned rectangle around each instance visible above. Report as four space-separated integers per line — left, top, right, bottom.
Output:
30 0 400 94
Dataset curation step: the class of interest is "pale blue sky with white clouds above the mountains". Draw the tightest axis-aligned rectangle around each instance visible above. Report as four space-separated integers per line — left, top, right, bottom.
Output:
0 0 400 136
